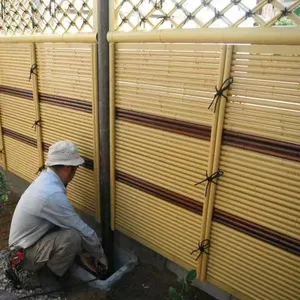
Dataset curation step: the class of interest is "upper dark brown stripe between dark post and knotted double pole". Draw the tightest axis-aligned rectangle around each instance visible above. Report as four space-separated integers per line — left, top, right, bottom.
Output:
116 108 210 141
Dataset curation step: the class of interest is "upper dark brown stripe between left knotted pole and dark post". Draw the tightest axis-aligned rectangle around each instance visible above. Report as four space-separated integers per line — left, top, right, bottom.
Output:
39 93 93 113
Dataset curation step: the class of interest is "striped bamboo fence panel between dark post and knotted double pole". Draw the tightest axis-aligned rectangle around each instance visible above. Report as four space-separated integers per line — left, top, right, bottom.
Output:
113 43 224 268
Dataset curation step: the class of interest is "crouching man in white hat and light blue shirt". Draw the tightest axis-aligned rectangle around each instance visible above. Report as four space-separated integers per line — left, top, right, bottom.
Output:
9 141 107 277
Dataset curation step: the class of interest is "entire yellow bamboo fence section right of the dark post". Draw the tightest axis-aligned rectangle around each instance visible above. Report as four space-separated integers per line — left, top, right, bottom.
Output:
110 30 300 299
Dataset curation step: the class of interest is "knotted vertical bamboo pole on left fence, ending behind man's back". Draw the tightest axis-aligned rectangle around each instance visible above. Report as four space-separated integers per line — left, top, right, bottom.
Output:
30 43 44 172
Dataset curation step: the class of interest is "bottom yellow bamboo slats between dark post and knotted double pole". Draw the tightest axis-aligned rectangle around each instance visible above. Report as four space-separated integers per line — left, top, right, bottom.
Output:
116 182 201 268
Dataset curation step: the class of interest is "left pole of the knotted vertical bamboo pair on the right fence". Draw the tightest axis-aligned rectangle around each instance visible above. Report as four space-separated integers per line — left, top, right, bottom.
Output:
198 46 226 276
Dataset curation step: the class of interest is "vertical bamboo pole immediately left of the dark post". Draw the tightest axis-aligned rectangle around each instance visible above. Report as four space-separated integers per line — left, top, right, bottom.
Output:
92 44 101 222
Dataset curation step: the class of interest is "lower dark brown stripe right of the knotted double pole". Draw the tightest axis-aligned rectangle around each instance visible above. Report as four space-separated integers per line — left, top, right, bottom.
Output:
213 209 300 256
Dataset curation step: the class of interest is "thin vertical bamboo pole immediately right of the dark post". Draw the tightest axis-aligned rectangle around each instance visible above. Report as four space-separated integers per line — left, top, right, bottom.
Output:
109 43 116 230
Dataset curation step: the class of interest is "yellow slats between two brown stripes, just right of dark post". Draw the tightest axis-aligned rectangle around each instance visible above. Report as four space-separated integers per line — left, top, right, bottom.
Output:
116 120 209 202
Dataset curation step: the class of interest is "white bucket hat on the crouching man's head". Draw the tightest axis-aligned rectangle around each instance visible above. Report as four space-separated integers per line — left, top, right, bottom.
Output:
45 141 84 167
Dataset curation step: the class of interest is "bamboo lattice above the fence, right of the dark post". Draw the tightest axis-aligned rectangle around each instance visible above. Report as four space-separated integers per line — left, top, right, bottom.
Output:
115 0 300 31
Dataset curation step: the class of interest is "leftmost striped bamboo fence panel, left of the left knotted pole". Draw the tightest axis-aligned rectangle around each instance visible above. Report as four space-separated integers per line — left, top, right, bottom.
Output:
0 44 39 181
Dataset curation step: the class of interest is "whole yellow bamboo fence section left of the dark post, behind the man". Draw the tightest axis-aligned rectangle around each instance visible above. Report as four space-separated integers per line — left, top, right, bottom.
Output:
0 39 100 218
